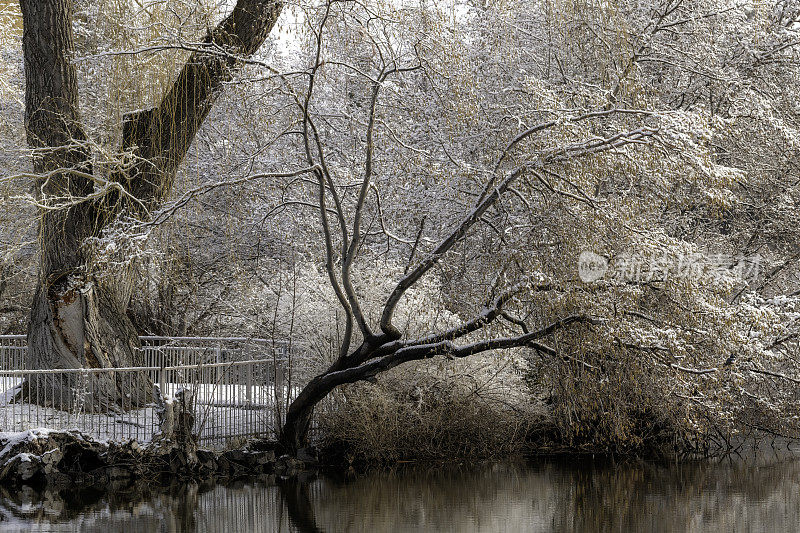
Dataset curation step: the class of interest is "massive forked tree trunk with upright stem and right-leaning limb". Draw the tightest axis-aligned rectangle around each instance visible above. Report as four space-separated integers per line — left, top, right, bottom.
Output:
20 0 282 410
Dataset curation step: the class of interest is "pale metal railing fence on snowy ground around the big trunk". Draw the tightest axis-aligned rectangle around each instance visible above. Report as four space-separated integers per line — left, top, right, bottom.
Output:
0 335 310 447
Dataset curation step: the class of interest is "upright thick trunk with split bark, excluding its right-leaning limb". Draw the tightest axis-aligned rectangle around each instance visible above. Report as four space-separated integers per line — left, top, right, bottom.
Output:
20 0 150 409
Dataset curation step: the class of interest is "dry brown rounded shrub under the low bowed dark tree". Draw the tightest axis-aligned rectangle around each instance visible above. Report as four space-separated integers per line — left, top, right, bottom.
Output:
320 362 535 464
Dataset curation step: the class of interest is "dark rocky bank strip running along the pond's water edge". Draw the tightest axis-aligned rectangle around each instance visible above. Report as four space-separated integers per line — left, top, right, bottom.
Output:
0 428 798 492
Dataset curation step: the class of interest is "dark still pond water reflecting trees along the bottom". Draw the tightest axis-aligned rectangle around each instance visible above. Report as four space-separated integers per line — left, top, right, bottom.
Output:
0 456 800 533
